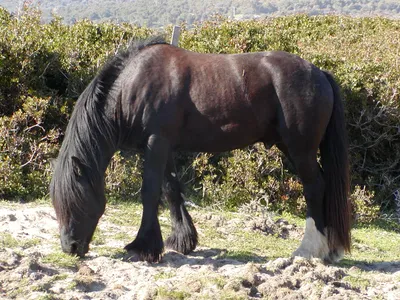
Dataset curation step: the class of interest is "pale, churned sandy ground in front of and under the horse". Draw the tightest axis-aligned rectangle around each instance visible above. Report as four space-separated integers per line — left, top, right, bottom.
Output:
0 205 400 300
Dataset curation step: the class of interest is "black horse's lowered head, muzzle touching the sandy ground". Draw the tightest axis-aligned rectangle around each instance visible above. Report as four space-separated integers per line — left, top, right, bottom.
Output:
50 156 106 257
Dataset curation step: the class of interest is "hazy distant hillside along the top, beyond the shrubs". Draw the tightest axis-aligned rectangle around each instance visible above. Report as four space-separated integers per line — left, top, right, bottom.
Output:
0 0 400 27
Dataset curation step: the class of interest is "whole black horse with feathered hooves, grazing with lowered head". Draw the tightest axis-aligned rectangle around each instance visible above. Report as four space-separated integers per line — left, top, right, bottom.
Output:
50 38 350 262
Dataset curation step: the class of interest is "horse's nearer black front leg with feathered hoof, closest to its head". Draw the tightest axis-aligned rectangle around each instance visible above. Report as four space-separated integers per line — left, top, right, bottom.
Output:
125 135 169 262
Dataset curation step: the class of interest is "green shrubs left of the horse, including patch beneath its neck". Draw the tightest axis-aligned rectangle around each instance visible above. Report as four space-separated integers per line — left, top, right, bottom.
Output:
0 7 153 200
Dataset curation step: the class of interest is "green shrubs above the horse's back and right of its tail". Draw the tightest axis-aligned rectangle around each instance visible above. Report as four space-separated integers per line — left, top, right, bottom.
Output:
181 15 400 218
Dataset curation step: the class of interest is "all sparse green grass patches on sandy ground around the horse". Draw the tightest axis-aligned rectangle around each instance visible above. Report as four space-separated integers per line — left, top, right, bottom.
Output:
0 199 400 268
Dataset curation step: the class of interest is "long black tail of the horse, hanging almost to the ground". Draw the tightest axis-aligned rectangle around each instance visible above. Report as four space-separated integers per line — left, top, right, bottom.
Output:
320 72 351 252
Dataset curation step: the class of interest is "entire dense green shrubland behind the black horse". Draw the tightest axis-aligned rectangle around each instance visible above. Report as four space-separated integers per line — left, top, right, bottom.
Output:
0 5 400 221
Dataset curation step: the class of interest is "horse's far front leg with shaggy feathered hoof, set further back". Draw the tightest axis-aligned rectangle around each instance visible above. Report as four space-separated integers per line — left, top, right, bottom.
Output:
163 155 198 254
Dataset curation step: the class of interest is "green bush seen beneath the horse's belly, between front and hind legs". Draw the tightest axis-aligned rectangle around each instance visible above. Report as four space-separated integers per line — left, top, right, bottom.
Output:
192 144 305 214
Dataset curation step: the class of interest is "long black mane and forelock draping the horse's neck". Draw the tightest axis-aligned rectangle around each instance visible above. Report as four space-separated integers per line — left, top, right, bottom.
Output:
50 37 167 224
